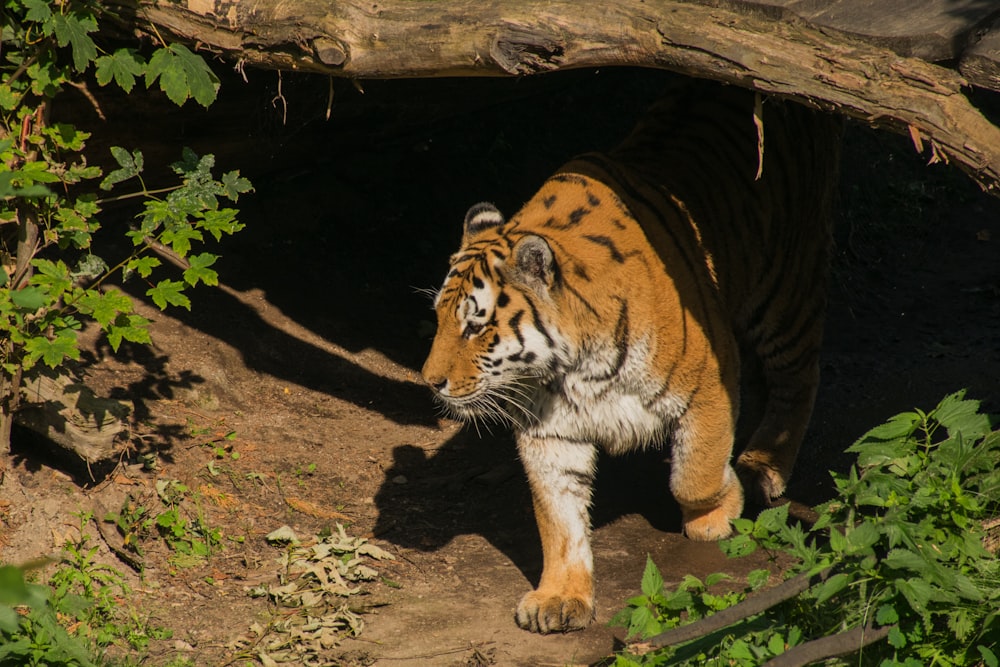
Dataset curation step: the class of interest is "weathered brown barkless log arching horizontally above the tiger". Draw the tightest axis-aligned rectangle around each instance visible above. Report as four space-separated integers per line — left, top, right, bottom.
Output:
110 0 1000 190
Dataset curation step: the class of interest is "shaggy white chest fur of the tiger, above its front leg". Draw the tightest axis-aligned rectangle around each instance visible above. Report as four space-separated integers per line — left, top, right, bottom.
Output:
522 341 685 454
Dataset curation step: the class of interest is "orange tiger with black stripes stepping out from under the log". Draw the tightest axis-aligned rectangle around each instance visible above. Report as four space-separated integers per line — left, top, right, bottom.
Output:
422 77 842 634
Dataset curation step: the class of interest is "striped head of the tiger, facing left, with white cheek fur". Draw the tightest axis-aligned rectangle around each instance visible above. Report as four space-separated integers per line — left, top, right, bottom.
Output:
423 203 565 422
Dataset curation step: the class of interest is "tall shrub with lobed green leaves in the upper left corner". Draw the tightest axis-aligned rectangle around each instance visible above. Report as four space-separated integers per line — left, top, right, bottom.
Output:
0 0 251 452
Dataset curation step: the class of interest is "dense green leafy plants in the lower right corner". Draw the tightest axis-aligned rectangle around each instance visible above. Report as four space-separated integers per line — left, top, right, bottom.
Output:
616 392 1000 667
